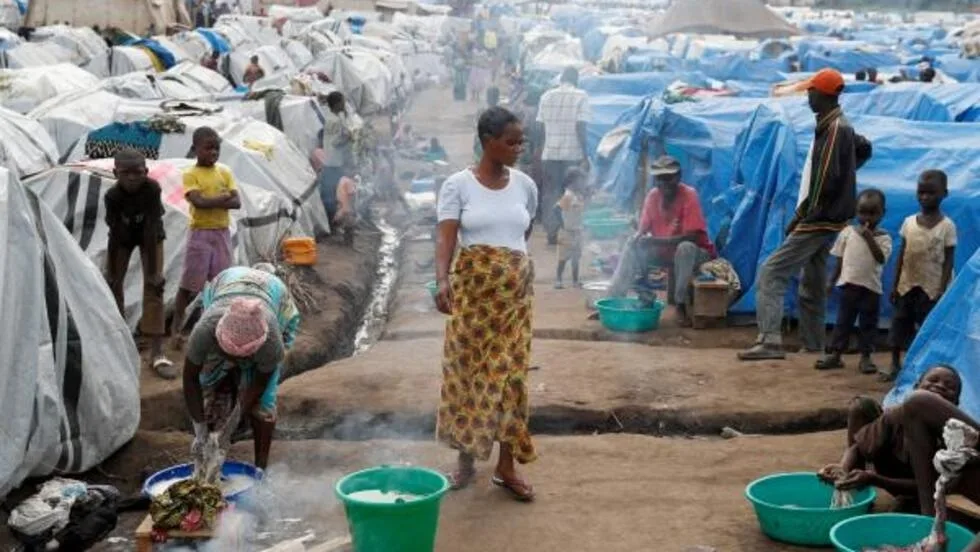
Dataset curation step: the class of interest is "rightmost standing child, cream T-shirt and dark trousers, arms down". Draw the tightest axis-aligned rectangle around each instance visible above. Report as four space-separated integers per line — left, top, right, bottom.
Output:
882 170 956 381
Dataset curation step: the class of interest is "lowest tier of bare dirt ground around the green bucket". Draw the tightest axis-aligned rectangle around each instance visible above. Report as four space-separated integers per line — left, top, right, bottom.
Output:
78 432 889 552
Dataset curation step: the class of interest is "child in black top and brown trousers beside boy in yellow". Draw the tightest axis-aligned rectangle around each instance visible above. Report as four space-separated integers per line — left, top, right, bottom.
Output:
105 148 177 379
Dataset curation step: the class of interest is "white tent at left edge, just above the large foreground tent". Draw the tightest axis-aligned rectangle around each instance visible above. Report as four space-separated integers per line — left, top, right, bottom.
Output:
0 108 58 178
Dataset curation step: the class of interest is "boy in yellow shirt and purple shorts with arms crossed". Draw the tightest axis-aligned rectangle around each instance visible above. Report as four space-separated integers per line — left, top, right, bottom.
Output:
173 127 242 346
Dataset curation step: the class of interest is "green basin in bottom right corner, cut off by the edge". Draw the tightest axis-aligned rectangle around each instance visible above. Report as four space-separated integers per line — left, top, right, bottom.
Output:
830 514 973 552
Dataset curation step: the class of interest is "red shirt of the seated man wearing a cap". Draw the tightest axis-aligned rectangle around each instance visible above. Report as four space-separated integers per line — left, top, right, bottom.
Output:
640 184 716 258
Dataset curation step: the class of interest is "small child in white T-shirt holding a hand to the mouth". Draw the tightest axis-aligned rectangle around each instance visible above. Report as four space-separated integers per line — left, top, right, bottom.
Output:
816 188 892 374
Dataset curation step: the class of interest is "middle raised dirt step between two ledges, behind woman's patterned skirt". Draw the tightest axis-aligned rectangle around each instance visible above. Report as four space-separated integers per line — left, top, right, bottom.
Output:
279 338 887 438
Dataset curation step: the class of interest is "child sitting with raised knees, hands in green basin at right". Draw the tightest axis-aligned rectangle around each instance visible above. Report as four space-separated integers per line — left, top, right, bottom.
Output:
817 365 960 515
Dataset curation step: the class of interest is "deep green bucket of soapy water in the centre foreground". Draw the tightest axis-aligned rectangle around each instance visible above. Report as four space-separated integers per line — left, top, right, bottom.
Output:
334 466 449 552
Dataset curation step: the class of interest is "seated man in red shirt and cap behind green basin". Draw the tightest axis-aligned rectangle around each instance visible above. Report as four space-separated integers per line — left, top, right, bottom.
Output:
609 155 715 325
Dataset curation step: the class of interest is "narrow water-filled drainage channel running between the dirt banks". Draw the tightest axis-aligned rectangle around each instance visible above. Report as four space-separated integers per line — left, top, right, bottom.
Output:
354 217 402 356
